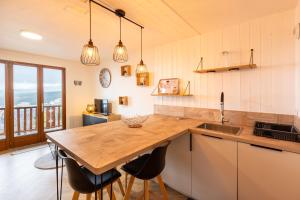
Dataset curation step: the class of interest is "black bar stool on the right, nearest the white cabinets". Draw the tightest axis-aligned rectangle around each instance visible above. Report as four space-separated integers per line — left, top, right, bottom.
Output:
122 142 170 200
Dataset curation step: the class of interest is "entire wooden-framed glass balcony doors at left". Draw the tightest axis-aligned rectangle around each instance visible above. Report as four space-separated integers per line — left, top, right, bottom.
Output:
0 61 65 150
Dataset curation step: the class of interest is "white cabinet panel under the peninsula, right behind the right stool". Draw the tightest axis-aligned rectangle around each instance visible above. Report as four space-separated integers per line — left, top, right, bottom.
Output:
162 134 191 196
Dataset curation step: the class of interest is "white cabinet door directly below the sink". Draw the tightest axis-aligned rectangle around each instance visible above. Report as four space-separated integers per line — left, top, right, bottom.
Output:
192 134 237 200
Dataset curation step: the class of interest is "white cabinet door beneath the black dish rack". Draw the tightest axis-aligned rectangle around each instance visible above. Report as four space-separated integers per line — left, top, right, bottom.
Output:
238 143 300 200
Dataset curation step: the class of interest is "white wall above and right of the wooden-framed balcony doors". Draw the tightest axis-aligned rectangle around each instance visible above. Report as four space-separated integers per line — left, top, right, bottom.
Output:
0 49 94 128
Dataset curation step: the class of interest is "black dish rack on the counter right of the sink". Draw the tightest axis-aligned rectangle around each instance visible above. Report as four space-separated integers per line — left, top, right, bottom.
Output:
254 122 300 142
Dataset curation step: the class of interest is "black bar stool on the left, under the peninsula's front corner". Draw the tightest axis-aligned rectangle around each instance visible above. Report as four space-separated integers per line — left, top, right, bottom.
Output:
58 150 125 200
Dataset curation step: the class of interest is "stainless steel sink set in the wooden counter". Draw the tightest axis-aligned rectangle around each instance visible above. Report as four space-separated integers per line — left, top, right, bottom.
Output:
197 123 241 135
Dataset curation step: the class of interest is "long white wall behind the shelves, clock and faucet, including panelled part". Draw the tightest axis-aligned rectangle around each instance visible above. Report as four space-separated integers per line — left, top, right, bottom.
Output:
97 10 296 114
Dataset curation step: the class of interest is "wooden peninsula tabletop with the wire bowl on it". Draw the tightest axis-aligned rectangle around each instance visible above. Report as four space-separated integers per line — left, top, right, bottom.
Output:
47 115 199 174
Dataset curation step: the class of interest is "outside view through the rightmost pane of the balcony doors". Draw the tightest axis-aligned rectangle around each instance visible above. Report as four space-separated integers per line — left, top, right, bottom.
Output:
43 68 62 131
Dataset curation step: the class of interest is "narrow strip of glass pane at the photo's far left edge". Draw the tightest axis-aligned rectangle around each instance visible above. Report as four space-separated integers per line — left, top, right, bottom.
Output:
0 63 5 140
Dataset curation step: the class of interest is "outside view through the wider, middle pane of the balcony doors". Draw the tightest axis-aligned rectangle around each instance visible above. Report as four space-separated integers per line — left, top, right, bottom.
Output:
13 65 37 137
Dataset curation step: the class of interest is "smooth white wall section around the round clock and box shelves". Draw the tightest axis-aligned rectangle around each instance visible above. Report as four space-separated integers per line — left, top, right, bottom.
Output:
94 49 154 116
